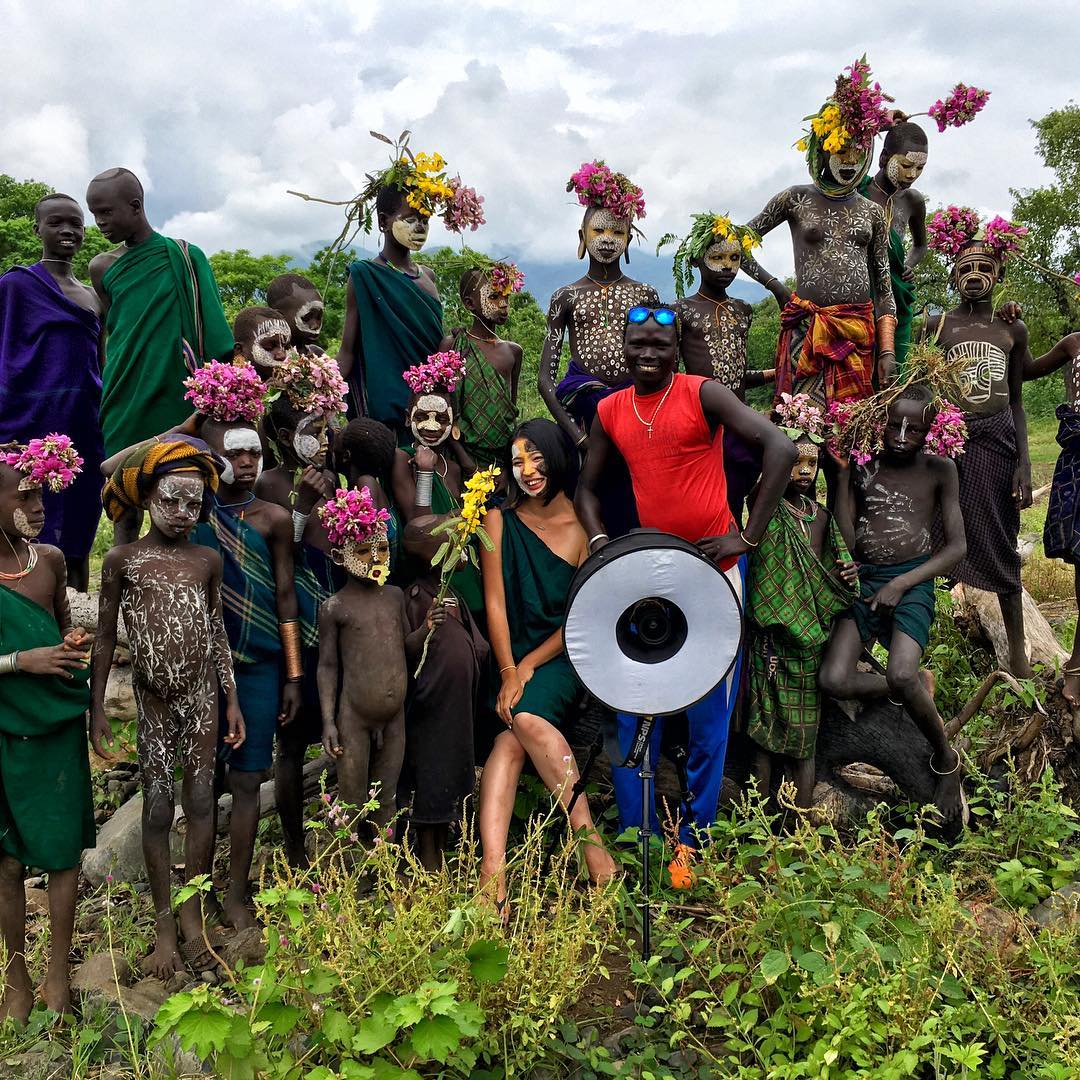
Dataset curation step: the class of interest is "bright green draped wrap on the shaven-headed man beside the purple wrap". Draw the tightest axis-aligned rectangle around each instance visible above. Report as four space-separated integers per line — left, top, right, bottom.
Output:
102 232 233 455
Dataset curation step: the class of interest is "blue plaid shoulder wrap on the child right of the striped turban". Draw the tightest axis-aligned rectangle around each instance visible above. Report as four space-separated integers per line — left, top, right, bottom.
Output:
191 500 281 665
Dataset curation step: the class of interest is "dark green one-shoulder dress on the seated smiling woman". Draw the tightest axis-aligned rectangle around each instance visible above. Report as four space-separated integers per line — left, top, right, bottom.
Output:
490 510 581 727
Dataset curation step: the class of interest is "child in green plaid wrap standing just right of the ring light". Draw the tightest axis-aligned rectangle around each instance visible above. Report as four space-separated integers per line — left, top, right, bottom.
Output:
746 406 859 807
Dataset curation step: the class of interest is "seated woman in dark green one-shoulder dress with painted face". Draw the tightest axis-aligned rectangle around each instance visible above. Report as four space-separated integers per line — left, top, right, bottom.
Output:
480 420 616 918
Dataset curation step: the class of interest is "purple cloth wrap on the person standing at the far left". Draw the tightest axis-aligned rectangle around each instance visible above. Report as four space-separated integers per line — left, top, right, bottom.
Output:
0 262 105 558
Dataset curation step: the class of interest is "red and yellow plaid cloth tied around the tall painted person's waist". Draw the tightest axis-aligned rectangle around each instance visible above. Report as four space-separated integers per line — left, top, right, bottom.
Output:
773 293 875 404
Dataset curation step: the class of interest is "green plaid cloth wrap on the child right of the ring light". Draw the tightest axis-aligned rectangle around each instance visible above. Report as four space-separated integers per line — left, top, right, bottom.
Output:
746 502 856 760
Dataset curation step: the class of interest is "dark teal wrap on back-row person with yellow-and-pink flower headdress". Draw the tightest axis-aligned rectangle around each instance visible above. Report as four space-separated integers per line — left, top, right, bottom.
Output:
349 259 443 433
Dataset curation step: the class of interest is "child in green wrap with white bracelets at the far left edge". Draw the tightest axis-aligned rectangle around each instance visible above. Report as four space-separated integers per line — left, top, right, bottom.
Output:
0 443 94 1022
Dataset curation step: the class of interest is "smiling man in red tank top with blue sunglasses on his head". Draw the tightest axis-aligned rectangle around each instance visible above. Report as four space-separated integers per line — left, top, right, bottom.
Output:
576 307 797 867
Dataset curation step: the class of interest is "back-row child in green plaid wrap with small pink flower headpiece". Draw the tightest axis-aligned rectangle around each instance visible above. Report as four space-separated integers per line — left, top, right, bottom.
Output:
440 262 525 469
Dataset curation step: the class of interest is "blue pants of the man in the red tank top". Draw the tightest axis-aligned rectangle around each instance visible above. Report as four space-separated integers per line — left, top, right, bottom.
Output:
611 557 745 847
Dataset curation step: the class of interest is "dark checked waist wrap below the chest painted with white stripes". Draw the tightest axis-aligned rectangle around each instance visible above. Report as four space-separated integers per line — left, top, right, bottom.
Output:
951 408 1021 595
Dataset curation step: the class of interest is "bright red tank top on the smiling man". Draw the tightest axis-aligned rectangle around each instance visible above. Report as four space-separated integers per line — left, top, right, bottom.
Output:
598 373 734 569
